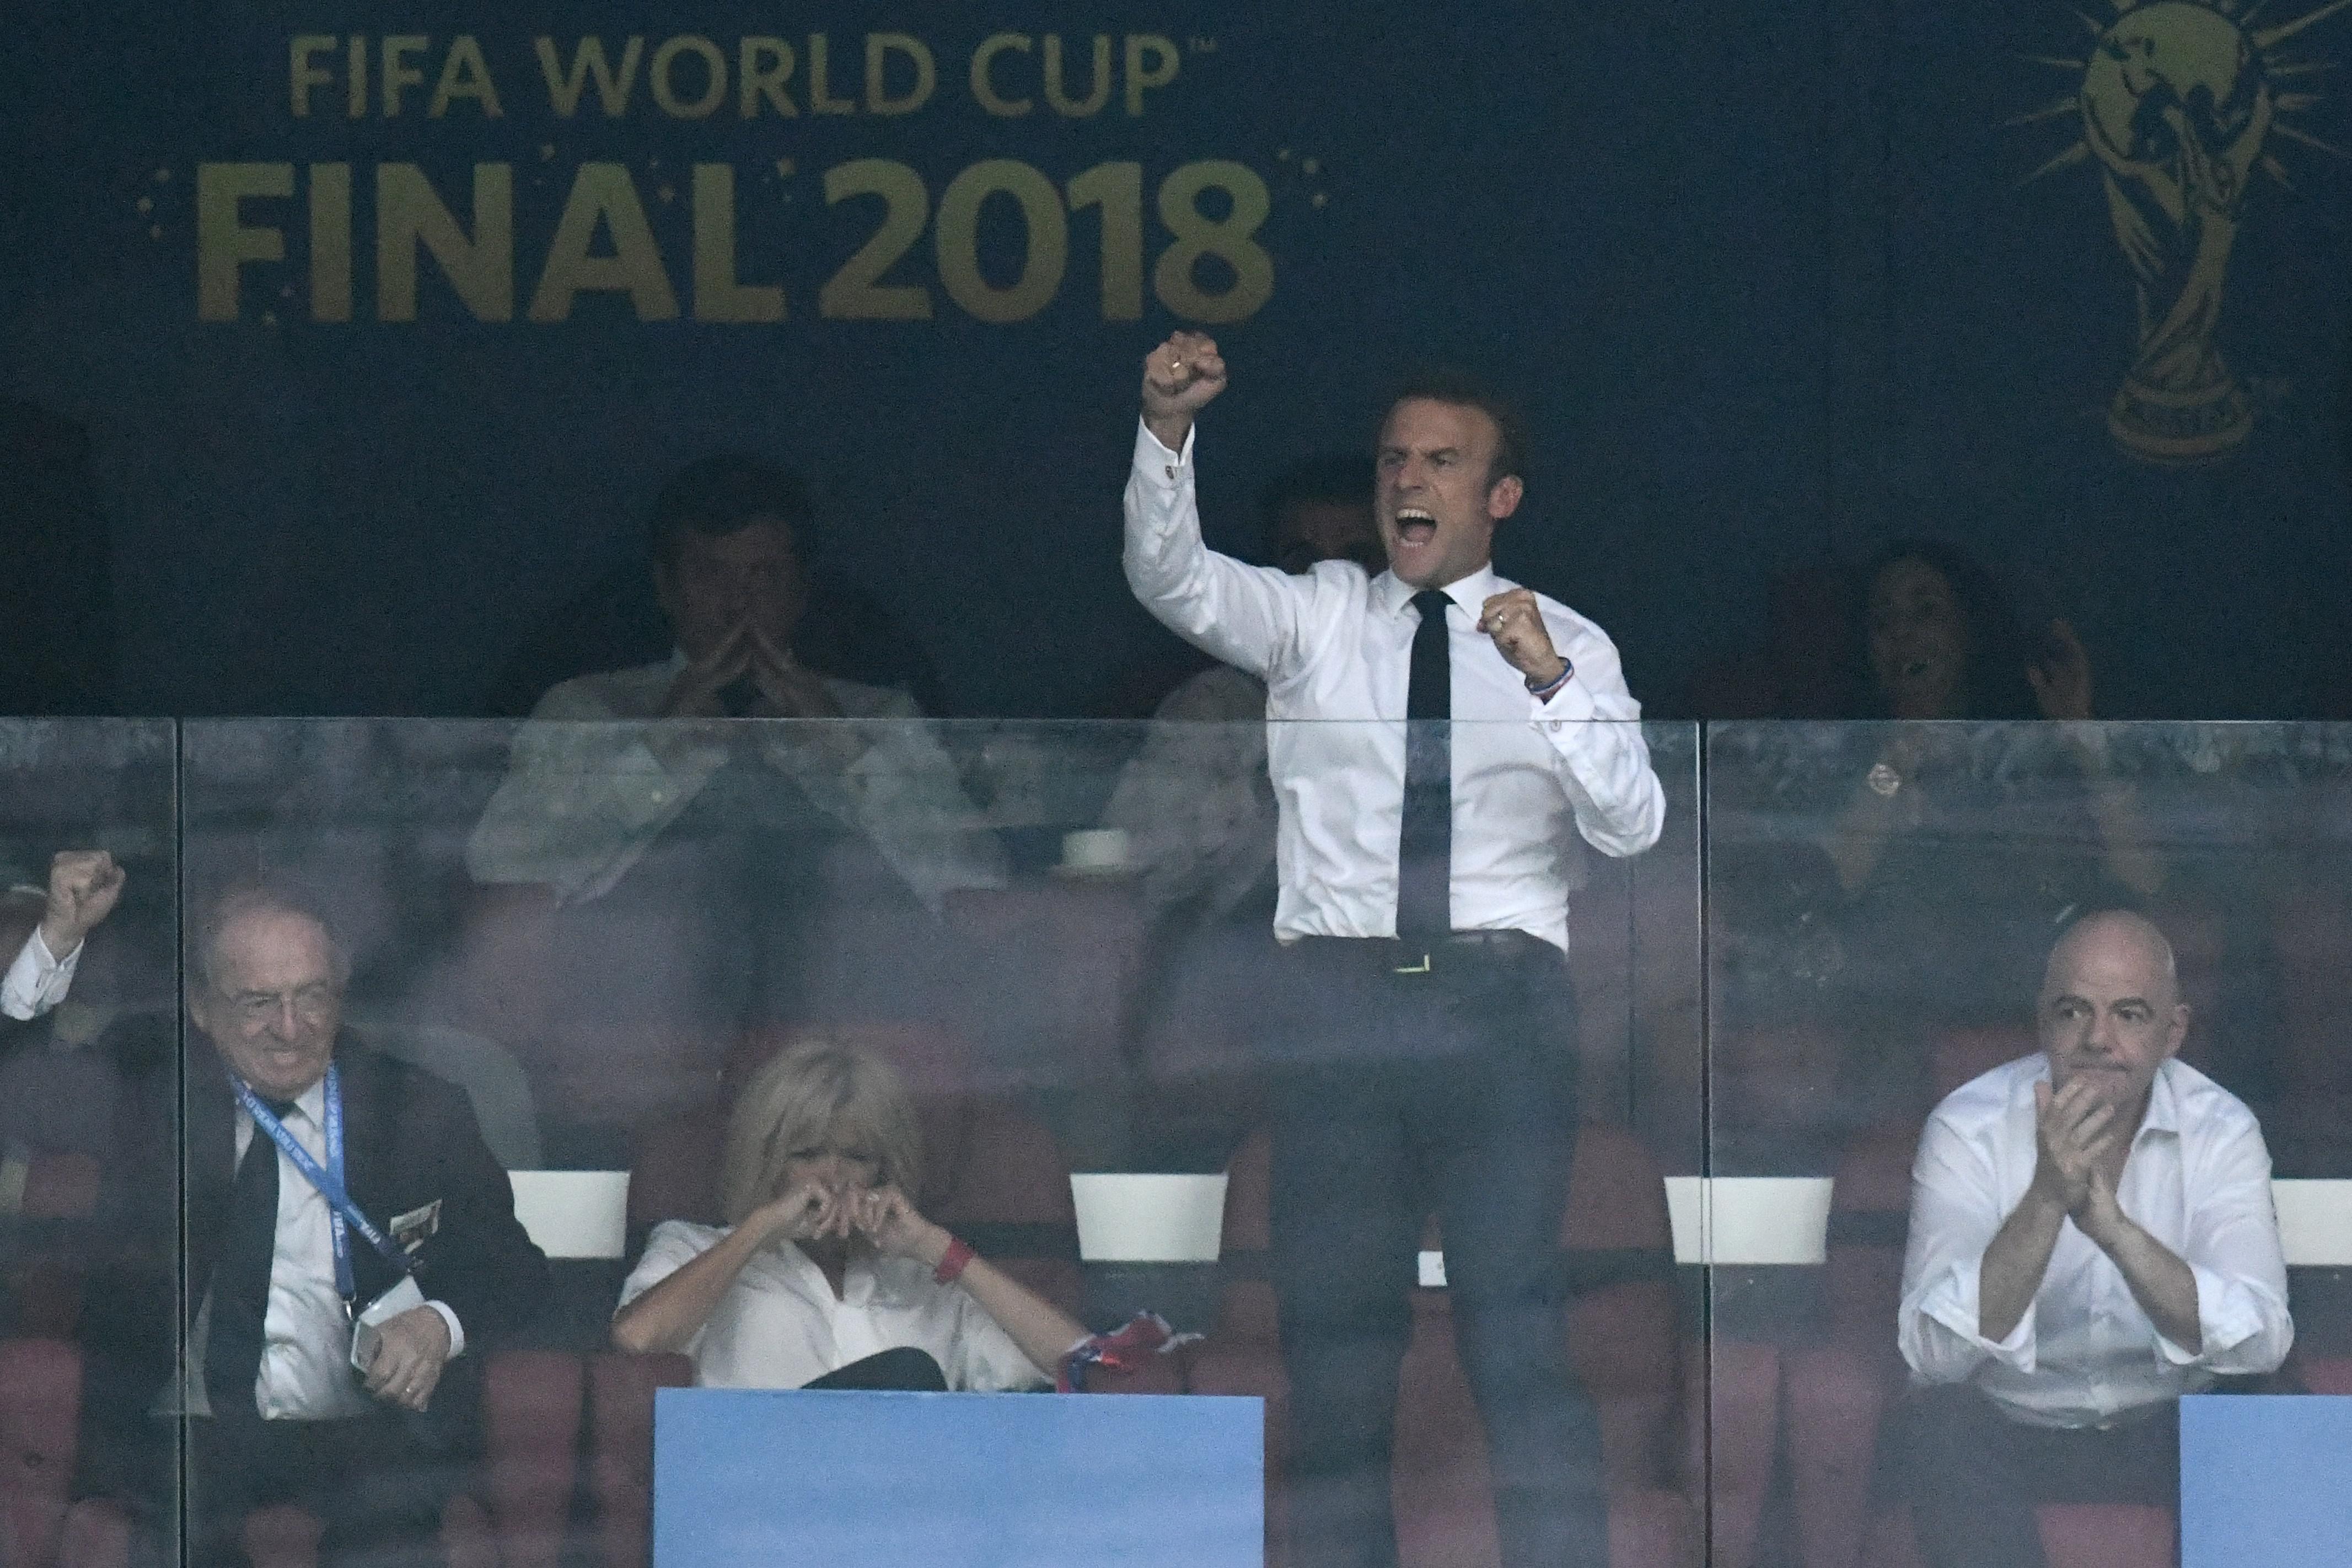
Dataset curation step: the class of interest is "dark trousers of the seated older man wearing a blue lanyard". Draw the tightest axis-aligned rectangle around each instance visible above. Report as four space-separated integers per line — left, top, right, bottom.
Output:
188 1410 468 1568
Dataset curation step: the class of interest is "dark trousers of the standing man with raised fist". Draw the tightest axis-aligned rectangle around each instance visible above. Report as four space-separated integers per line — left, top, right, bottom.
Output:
1270 938 1609 1568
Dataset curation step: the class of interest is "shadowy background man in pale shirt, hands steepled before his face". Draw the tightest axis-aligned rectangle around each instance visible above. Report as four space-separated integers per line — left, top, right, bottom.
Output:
466 456 1005 1142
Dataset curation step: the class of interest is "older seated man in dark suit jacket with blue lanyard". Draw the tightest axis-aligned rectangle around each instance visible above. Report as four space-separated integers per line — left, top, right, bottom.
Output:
88 891 548 1566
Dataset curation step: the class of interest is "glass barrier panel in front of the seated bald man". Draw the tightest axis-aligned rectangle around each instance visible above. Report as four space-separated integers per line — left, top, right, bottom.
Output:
1707 722 2352 1563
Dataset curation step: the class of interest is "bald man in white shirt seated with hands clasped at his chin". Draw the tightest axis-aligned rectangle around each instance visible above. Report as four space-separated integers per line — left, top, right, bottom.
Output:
1891 912 2296 1568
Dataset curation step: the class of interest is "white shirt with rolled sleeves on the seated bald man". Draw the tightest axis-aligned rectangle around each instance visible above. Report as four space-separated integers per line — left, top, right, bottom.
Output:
1898 1051 2296 1427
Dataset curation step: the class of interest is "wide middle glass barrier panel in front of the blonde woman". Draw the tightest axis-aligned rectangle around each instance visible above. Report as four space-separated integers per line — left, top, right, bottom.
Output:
184 719 1703 1561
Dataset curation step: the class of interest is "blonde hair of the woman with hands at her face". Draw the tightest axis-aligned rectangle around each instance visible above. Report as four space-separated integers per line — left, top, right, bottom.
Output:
719 1037 922 1225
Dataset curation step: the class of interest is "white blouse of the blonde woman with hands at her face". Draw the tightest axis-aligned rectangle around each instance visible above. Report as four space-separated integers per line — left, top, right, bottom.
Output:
621 1220 1046 1394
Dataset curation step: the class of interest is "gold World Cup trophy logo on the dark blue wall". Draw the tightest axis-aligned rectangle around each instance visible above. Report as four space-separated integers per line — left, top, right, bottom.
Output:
2011 0 2352 463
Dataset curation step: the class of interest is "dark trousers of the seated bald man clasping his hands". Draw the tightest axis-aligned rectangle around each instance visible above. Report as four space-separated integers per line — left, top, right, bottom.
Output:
1889 1382 2181 1568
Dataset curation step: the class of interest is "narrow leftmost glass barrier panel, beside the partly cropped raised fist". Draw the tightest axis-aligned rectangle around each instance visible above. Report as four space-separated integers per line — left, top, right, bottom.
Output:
0 719 179 1561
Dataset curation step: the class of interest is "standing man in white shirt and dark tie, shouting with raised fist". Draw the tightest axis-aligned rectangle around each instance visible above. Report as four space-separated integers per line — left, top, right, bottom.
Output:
1124 331 1665 1568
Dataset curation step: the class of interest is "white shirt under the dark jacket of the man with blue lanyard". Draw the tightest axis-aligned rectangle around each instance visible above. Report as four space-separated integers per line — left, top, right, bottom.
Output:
184 1081 466 1420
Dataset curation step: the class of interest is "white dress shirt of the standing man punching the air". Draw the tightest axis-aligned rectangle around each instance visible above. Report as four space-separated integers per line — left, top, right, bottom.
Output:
1124 426 1665 950
